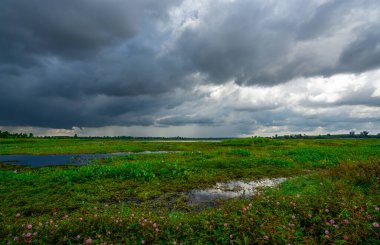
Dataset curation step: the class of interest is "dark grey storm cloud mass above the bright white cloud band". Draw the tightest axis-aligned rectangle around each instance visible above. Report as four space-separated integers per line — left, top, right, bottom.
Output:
0 0 380 131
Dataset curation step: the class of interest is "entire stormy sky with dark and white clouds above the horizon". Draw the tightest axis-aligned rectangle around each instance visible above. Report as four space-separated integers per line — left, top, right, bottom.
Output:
0 0 380 137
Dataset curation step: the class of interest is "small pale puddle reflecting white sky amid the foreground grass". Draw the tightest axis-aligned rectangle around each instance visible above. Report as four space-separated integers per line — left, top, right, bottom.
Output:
189 178 286 204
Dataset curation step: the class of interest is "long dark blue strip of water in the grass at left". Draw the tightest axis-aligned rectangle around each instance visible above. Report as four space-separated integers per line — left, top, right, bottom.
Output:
0 151 178 167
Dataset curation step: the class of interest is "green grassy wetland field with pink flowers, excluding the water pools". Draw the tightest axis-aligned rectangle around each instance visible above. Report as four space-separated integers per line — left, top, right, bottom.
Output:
0 138 380 244
